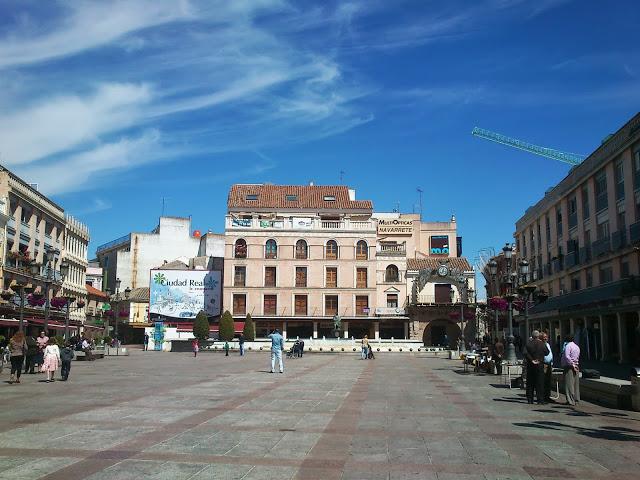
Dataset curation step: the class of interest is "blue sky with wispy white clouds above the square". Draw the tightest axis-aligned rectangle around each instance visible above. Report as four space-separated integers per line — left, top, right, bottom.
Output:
0 0 640 294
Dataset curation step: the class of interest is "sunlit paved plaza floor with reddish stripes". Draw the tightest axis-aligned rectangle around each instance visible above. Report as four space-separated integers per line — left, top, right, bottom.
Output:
0 351 640 480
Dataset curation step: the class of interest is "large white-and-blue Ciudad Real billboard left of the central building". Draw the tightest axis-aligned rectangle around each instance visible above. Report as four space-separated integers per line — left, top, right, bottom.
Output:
149 270 221 319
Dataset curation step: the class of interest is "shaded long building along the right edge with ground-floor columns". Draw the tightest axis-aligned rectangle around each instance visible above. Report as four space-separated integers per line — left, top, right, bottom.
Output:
515 113 640 363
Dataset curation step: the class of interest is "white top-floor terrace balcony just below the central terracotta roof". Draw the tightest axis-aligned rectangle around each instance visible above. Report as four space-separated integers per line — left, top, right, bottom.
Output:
225 216 377 232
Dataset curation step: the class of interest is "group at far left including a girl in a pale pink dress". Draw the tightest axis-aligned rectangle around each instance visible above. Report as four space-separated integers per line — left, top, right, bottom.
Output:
8 331 75 384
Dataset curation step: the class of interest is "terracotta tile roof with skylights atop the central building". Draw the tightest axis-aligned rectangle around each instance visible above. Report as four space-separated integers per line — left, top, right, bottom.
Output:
227 184 373 210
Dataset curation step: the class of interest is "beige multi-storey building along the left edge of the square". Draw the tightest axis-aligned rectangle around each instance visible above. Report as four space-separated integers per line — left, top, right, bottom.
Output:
0 167 89 333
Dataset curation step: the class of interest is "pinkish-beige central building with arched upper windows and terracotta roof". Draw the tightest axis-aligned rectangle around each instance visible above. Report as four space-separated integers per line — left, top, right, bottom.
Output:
223 184 396 338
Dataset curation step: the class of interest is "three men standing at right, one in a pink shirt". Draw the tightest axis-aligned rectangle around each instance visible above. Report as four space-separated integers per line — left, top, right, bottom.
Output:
524 330 580 406
